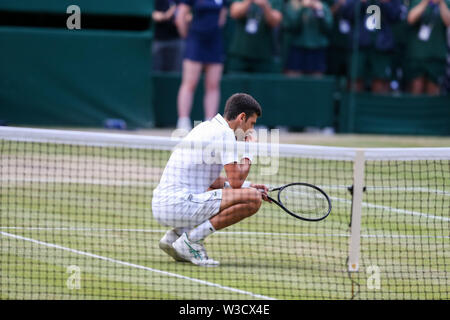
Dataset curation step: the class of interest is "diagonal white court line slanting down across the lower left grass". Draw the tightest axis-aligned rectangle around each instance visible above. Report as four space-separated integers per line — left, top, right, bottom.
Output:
0 231 276 300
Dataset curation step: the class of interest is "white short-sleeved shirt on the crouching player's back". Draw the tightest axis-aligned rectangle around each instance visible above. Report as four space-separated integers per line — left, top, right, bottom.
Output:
153 114 238 204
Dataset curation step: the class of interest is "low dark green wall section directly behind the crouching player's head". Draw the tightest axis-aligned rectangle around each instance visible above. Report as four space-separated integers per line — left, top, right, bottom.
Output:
153 73 336 128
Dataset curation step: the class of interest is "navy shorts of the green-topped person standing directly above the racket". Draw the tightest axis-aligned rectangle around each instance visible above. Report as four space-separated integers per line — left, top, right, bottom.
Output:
285 46 327 73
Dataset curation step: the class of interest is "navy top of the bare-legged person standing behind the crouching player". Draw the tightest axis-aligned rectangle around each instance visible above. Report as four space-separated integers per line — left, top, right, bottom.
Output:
180 0 227 33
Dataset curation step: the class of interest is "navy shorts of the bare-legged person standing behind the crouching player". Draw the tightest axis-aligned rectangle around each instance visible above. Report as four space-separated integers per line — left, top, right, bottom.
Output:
184 31 225 63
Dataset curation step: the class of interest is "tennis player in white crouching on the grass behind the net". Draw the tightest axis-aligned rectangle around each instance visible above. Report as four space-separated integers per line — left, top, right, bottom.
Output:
152 93 268 267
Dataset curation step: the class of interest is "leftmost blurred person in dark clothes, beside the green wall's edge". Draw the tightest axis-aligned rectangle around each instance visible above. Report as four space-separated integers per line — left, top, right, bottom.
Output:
152 0 183 72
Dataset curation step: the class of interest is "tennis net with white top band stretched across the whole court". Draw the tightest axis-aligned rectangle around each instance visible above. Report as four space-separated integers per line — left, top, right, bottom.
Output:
0 127 450 300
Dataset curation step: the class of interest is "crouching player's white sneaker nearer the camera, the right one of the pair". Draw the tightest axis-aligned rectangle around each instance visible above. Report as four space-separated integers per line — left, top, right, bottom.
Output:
172 232 219 267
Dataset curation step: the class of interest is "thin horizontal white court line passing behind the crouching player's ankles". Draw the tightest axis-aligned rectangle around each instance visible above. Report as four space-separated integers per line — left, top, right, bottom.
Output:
0 227 450 239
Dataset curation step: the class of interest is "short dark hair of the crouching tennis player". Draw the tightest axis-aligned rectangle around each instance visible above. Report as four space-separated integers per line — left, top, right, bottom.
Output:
224 93 262 120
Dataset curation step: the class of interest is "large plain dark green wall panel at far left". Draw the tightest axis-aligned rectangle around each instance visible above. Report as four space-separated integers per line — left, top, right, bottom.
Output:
0 27 154 128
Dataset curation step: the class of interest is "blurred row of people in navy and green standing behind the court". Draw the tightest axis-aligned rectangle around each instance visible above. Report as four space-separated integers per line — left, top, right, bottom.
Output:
152 0 450 129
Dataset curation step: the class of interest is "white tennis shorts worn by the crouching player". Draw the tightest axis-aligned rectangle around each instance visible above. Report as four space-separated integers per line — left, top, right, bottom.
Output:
152 189 222 228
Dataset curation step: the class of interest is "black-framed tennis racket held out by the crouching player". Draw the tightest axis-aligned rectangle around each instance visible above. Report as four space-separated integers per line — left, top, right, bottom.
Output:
259 182 331 221
